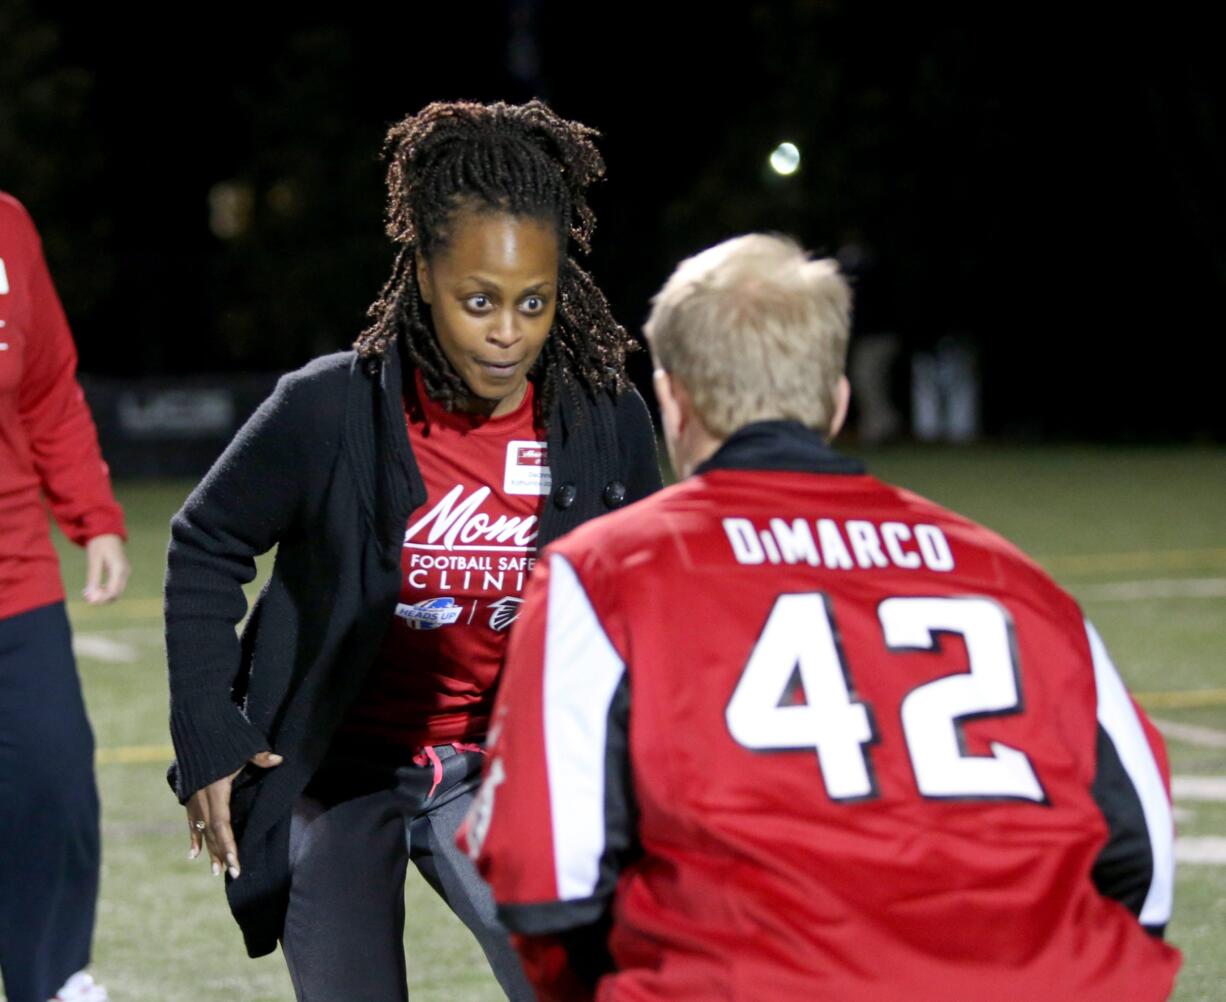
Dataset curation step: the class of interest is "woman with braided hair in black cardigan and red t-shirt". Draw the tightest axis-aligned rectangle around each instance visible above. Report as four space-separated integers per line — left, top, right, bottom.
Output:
166 101 660 1002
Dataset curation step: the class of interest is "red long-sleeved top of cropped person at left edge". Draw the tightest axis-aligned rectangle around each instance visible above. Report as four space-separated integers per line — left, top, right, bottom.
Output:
0 191 125 618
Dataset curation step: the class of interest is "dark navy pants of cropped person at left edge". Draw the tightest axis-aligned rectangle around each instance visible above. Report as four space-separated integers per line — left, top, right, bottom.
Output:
0 602 99 1002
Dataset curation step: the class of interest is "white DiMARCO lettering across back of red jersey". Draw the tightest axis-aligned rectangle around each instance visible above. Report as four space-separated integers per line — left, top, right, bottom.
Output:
723 519 954 572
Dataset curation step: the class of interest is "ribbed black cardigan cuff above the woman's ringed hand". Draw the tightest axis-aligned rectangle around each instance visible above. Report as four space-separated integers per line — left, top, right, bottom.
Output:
168 699 270 803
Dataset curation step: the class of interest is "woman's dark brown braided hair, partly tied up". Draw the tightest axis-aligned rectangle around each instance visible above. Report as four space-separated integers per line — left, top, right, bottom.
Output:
353 101 638 416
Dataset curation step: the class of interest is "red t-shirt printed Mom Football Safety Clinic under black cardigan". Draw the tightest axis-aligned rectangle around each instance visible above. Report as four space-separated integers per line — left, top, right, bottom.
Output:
343 374 549 748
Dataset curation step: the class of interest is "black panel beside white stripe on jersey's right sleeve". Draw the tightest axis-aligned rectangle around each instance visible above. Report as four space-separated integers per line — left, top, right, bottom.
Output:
1091 724 1161 935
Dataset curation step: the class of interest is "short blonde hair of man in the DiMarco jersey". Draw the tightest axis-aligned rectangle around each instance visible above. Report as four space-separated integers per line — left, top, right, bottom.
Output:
644 233 851 439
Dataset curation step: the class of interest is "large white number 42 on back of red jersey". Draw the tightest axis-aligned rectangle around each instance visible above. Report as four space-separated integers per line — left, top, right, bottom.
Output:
725 592 1047 803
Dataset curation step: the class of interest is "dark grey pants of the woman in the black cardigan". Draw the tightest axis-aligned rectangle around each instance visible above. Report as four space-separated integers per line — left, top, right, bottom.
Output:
281 747 535 1002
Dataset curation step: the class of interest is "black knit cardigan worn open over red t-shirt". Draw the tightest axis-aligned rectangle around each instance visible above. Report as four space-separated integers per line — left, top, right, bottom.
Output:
166 348 661 957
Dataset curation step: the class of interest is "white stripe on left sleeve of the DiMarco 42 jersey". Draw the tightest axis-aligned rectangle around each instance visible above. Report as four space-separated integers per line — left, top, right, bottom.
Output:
544 553 625 900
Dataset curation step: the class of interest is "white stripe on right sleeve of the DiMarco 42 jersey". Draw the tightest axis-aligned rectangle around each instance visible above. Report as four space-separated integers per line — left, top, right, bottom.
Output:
1085 621 1175 926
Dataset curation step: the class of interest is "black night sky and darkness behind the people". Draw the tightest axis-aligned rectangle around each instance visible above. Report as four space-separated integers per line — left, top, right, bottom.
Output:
0 0 1226 442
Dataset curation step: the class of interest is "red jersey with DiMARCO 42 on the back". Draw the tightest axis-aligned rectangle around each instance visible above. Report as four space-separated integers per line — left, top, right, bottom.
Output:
466 429 1179 1002
